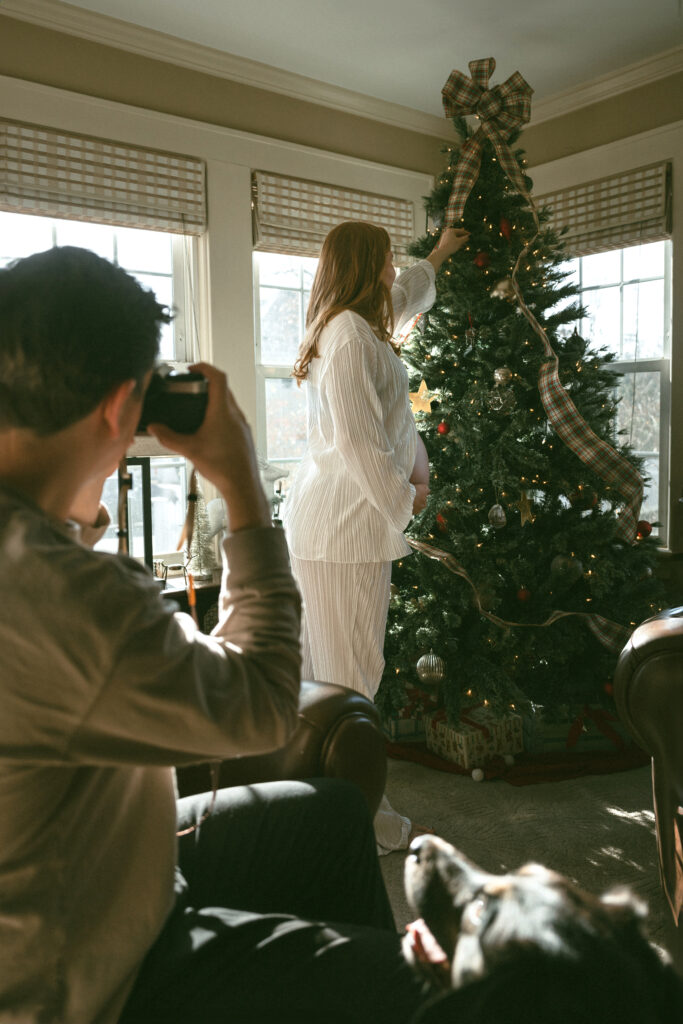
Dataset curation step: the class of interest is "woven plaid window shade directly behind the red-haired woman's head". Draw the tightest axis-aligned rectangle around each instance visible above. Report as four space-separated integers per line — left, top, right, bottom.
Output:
252 171 415 264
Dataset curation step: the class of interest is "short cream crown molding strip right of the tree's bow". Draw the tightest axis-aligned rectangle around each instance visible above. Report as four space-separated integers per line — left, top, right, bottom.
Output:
530 46 683 125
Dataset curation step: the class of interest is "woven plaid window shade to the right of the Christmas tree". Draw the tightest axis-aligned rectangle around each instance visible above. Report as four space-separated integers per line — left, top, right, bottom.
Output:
536 163 671 256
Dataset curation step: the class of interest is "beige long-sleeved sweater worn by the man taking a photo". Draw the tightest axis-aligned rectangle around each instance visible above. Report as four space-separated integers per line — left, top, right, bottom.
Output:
0 487 300 1024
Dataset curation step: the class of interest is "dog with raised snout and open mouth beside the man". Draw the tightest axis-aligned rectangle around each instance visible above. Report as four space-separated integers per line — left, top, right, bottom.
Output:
403 836 683 1024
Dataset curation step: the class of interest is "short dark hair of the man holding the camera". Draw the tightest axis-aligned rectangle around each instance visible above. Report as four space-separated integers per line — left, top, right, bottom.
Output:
0 246 171 435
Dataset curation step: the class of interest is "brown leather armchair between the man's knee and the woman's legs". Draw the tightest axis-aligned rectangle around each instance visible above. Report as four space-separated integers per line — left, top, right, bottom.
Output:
177 682 386 816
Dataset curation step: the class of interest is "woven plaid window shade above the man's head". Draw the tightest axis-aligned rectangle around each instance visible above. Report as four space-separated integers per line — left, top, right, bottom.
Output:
0 121 206 234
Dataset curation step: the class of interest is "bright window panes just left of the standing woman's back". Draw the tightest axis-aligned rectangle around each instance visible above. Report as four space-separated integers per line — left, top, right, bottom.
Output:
254 252 317 479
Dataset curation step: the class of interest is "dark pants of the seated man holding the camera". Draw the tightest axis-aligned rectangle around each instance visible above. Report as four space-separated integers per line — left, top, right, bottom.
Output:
120 779 420 1024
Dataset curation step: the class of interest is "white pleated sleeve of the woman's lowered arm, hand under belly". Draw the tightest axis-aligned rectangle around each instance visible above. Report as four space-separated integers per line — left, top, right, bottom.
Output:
321 324 415 531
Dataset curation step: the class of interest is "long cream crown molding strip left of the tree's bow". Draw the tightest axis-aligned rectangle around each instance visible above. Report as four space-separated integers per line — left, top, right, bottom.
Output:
0 0 450 139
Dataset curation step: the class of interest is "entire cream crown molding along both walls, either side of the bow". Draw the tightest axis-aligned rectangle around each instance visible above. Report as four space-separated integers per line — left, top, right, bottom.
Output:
5 0 683 139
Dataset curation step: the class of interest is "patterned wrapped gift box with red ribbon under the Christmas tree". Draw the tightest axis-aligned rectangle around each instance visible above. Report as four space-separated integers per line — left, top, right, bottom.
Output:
424 706 524 769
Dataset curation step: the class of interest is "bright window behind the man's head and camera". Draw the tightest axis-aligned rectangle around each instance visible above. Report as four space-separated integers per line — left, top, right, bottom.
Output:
0 211 194 560
